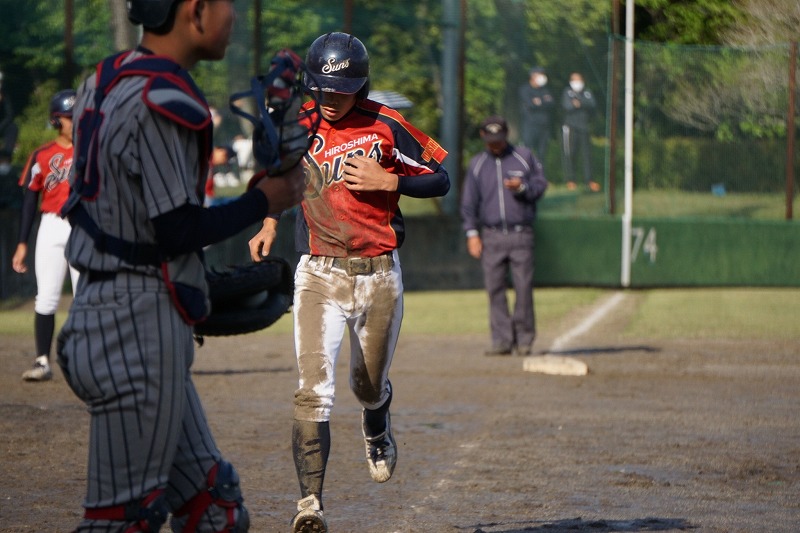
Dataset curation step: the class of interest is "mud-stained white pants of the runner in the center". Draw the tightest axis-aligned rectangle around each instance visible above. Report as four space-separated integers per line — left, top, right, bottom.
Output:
294 250 403 422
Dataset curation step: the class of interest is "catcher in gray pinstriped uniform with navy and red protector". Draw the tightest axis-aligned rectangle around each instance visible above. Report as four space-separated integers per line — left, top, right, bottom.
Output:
58 0 304 533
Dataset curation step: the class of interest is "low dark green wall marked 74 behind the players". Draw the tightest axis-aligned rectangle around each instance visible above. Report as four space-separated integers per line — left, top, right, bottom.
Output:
0 210 800 299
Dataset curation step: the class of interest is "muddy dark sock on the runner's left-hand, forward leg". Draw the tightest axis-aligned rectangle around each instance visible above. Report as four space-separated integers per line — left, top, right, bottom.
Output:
292 420 331 501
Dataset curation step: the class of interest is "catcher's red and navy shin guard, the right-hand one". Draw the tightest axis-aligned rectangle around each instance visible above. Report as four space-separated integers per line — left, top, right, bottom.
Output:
170 461 250 533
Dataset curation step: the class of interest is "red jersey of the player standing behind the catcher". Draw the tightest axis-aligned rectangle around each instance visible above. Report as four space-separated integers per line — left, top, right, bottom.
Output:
19 141 73 214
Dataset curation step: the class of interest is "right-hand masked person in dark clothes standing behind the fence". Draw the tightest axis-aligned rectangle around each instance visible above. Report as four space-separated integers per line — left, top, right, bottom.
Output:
561 72 600 192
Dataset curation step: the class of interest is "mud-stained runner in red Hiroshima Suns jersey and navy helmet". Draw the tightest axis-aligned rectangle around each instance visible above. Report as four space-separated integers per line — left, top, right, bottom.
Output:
249 33 450 532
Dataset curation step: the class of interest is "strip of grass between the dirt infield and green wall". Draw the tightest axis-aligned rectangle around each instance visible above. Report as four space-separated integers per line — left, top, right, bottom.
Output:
0 288 800 341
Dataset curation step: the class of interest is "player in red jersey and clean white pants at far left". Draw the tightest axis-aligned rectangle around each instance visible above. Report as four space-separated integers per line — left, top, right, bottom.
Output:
11 89 78 381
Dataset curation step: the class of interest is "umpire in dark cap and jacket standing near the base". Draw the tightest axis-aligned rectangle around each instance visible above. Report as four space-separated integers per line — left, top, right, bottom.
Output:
461 116 547 355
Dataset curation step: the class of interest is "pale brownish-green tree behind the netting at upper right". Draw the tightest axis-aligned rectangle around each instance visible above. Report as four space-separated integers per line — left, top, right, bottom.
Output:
642 0 800 140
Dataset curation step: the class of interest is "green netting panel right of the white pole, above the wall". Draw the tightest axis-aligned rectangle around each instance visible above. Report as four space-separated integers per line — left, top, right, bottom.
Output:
609 35 796 219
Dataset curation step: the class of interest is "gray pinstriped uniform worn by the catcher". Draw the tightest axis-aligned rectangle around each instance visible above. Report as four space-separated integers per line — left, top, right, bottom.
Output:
58 50 233 532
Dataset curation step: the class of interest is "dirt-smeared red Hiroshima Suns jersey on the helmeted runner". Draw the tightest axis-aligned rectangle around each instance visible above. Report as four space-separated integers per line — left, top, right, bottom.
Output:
296 100 447 257
